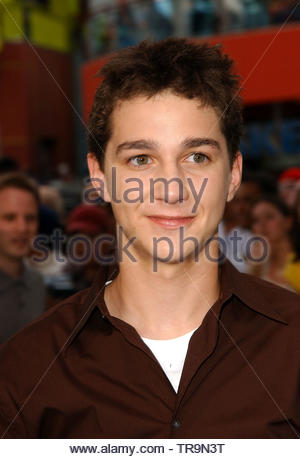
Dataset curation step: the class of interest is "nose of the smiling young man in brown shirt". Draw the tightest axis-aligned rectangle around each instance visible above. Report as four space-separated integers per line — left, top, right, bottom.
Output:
150 164 189 204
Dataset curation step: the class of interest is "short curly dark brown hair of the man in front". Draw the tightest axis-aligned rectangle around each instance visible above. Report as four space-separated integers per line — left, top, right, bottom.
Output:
88 38 243 169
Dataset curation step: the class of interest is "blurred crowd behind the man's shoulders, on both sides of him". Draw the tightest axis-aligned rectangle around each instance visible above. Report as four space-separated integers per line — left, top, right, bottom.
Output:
0 158 300 342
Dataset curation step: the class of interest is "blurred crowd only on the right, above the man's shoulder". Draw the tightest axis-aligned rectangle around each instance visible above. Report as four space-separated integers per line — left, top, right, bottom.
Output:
219 167 300 293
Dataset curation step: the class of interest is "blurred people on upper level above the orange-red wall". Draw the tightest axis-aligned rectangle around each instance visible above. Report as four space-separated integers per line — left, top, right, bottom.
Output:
85 0 300 56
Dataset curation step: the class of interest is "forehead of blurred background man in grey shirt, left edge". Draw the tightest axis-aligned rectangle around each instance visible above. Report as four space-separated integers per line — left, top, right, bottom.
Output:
0 187 38 213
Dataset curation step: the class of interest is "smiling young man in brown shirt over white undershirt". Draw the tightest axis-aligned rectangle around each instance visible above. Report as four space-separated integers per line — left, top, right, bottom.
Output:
0 39 300 438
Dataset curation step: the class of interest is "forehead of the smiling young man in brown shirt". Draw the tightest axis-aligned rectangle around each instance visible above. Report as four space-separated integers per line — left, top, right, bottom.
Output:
111 91 225 143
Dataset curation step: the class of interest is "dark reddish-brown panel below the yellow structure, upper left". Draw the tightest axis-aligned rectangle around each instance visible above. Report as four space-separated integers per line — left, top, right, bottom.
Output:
0 43 75 174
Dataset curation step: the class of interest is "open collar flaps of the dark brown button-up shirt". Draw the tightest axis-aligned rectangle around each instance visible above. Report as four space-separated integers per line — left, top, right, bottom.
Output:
67 259 288 346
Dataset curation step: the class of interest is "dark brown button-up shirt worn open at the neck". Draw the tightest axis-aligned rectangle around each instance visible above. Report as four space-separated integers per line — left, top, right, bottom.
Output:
0 262 300 438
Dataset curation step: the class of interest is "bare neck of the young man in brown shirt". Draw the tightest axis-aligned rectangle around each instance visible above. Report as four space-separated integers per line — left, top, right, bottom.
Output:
104 243 219 339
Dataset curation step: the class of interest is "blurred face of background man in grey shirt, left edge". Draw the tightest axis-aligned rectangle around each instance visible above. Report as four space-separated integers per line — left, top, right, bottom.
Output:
0 188 38 260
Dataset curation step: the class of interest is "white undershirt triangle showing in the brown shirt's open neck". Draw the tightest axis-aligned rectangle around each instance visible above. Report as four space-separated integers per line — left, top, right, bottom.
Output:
141 329 196 392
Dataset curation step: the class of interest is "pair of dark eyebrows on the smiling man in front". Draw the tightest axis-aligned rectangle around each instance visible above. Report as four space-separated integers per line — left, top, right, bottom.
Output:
116 137 221 155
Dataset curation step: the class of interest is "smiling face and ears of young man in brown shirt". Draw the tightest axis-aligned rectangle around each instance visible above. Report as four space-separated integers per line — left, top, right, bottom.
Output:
89 92 241 263
